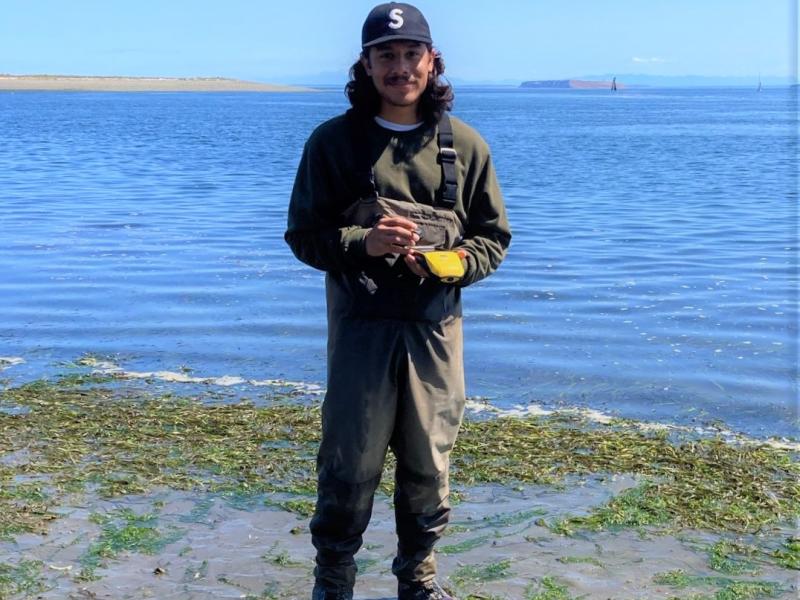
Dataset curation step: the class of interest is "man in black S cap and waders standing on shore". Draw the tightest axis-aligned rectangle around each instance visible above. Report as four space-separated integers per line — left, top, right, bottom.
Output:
286 2 511 600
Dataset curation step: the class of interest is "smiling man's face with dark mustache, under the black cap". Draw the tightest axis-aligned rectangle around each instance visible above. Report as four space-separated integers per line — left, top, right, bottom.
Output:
361 41 433 111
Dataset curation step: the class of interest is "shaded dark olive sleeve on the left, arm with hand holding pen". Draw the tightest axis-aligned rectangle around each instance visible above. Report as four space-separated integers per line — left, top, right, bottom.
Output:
284 135 369 271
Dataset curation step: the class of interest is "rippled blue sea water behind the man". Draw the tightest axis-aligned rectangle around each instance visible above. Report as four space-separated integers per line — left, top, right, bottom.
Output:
0 89 798 436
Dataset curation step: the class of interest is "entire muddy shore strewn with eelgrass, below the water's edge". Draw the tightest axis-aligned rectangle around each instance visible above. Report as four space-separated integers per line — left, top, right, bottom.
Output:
0 356 800 600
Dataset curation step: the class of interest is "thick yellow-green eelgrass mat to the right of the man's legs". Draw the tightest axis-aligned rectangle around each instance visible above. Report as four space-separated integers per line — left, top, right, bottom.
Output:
453 418 800 532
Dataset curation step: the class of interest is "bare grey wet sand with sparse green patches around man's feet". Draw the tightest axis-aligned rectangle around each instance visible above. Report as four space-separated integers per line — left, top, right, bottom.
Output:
0 477 797 600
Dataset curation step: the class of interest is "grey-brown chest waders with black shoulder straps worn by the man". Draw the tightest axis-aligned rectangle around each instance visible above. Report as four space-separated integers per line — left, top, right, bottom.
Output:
311 115 465 589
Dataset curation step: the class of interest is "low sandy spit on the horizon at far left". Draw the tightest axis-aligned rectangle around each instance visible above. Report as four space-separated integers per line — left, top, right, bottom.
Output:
0 74 311 92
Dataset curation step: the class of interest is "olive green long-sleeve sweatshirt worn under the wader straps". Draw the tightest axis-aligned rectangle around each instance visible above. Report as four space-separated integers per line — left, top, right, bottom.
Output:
285 110 511 320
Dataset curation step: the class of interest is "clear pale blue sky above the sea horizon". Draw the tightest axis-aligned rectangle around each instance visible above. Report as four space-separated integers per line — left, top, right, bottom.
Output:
0 0 798 83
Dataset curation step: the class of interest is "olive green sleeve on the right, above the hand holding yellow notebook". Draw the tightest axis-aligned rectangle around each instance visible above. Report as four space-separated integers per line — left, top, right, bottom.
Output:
457 155 511 287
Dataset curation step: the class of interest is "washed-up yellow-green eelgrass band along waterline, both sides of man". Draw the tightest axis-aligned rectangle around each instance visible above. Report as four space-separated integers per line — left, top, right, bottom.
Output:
0 377 800 548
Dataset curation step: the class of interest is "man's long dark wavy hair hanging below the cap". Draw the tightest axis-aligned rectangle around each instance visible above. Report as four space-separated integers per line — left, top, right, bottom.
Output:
344 46 454 122
